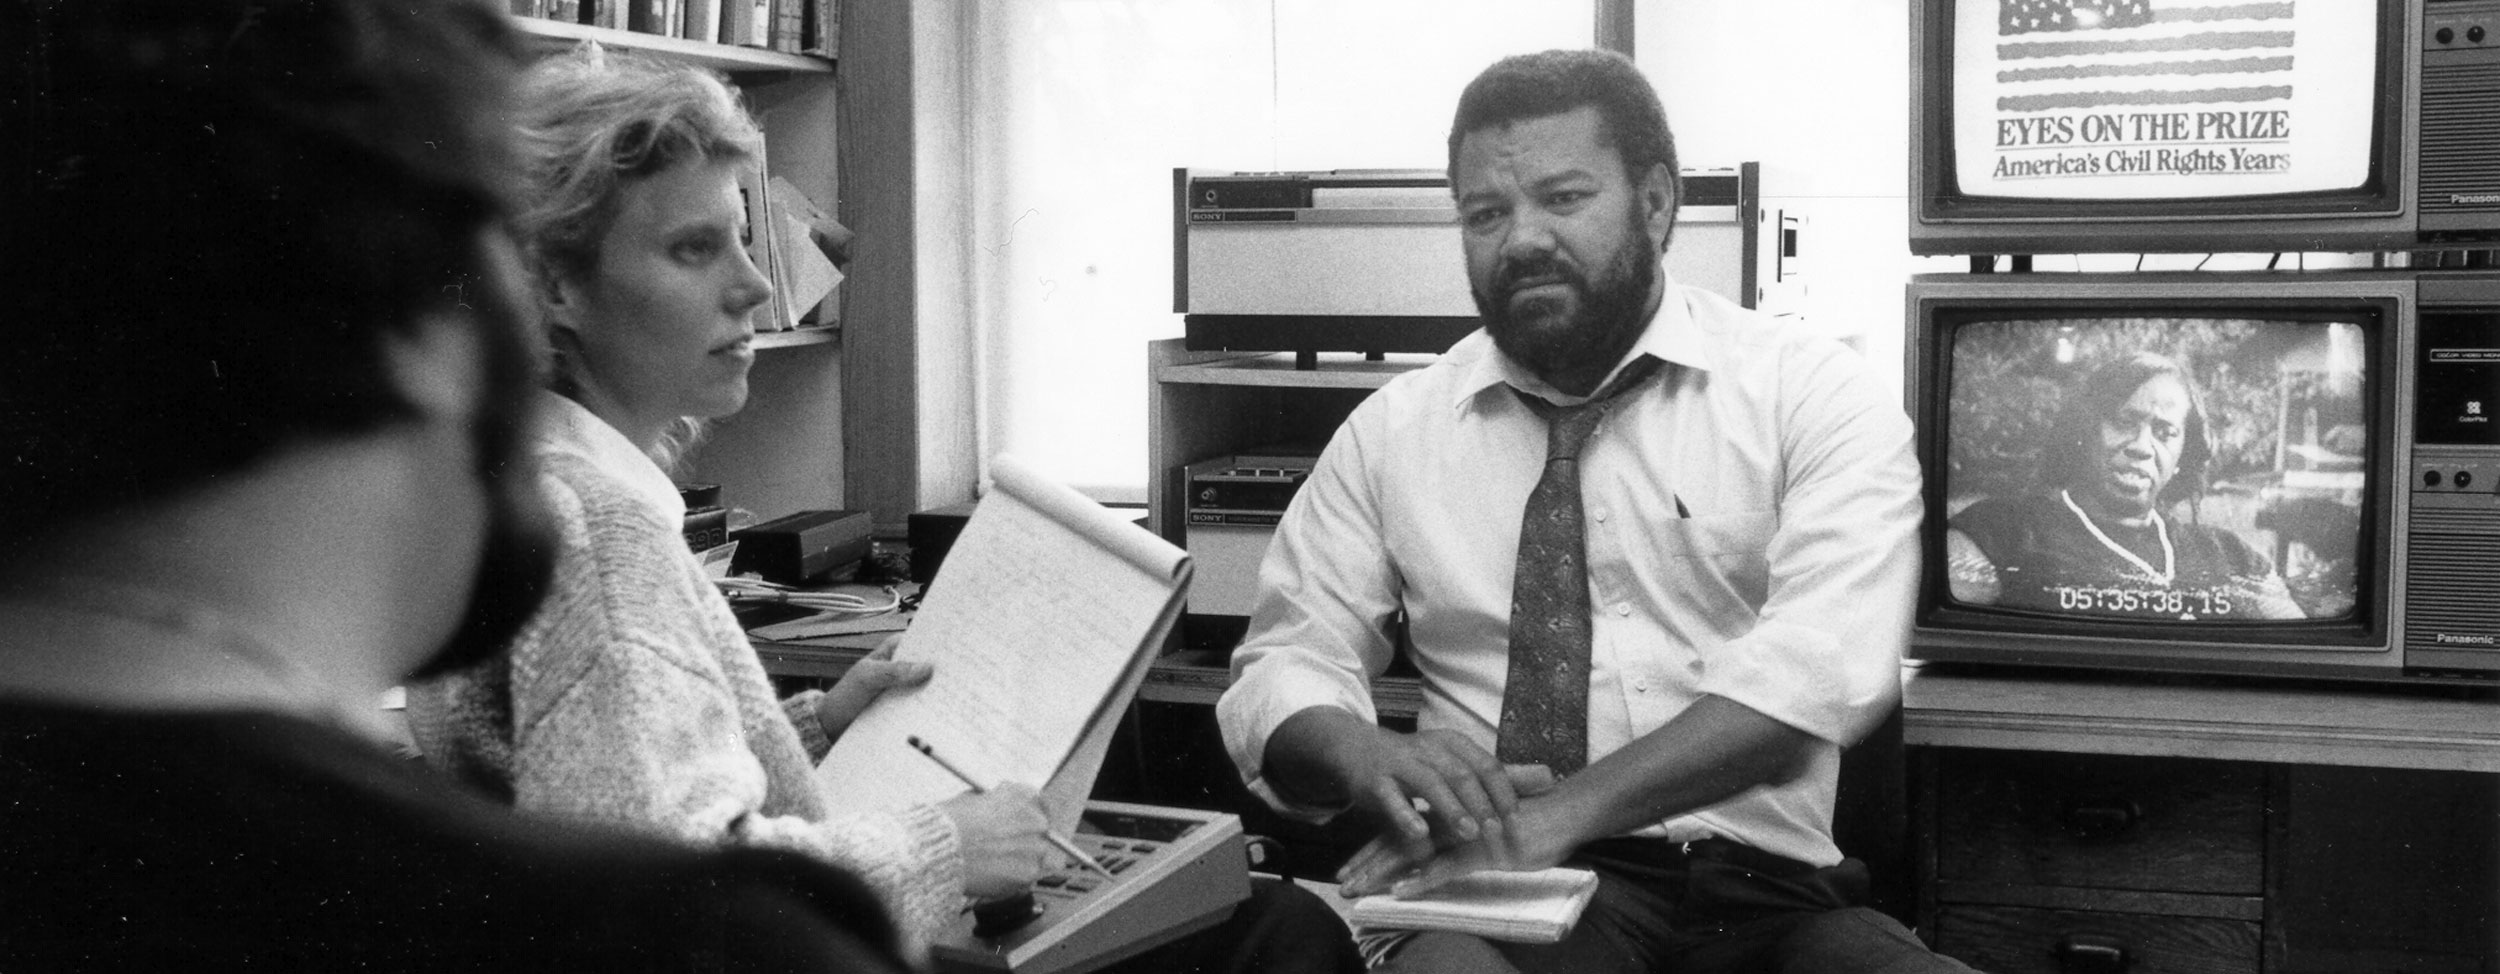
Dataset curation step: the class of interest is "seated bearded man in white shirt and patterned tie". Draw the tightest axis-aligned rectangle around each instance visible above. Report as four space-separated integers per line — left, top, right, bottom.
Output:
1220 50 1963 972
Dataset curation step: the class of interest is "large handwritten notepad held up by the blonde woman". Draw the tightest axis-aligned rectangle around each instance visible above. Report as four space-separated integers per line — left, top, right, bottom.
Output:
815 455 1190 834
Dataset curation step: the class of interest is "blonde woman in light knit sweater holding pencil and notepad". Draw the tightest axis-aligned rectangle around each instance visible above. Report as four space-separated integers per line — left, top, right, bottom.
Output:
408 47 1053 954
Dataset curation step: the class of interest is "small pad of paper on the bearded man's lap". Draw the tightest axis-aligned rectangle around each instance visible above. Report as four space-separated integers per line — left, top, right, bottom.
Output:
1348 867 1598 944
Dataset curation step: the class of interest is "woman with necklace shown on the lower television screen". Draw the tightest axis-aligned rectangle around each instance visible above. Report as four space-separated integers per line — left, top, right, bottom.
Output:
1945 352 2303 619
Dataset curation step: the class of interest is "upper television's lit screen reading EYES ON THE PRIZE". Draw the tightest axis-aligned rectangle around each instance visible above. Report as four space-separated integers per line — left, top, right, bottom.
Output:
1950 0 2380 200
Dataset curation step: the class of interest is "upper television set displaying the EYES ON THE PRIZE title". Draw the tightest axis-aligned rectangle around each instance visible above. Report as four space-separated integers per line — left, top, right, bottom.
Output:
1910 0 2500 255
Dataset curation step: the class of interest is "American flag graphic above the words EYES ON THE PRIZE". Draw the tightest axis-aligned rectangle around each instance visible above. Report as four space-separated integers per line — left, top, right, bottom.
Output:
1998 0 2290 112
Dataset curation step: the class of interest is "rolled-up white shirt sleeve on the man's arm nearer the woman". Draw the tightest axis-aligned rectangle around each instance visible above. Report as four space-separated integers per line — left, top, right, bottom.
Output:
1215 412 1398 822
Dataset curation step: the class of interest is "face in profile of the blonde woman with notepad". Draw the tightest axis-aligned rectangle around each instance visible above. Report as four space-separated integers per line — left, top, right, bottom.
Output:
555 162 773 425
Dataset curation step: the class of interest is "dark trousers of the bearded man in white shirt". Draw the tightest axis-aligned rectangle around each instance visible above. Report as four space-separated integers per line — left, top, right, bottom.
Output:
1380 839 1970 974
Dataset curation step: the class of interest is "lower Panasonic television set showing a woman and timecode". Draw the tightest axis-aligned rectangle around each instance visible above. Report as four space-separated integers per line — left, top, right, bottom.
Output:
1905 270 2500 682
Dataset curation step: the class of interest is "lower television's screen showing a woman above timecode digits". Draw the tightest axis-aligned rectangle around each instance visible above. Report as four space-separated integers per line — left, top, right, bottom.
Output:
1943 315 2373 624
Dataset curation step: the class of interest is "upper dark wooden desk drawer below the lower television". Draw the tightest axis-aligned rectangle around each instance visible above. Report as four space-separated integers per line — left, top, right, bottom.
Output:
1935 749 2265 897
